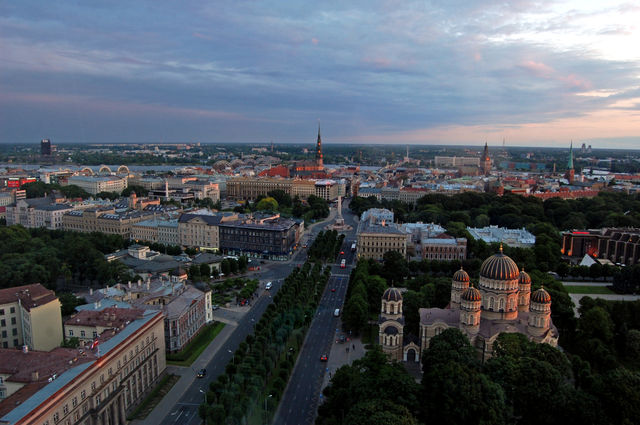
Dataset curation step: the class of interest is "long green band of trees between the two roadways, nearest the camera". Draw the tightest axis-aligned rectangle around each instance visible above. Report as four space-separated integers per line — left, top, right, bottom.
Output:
199 263 331 424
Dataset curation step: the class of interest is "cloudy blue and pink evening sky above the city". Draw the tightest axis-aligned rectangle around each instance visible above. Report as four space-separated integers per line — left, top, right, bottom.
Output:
0 0 640 148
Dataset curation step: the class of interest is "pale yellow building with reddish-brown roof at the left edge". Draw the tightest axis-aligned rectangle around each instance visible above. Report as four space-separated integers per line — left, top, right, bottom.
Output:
0 283 62 351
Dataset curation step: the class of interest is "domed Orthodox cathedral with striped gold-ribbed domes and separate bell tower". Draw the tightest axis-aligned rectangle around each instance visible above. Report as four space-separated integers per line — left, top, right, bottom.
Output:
379 247 558 362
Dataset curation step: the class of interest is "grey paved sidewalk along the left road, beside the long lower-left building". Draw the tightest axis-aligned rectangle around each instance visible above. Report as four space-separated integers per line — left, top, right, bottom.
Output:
129 324 236 425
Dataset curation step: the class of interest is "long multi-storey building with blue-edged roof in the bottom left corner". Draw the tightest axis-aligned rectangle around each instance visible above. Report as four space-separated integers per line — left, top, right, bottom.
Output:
0 308 166 425
